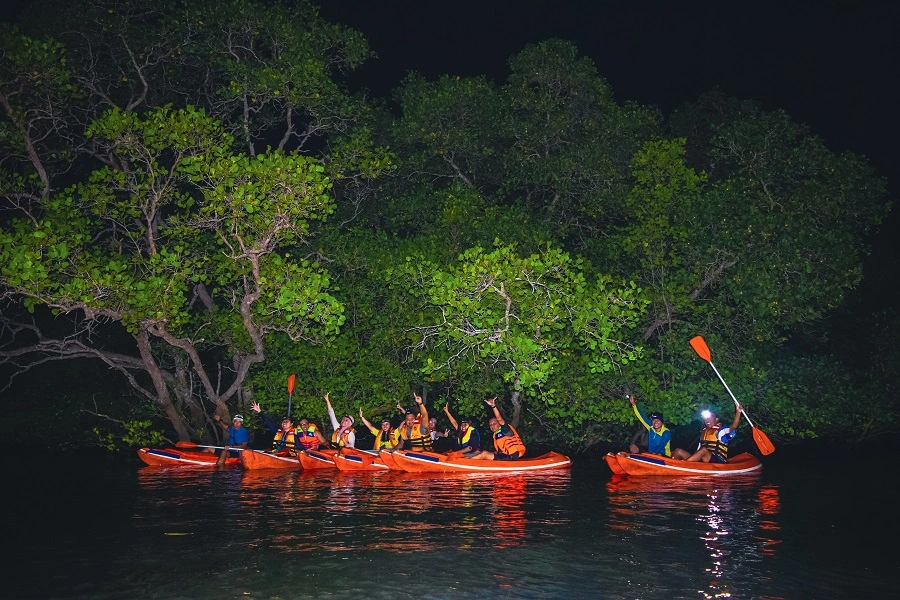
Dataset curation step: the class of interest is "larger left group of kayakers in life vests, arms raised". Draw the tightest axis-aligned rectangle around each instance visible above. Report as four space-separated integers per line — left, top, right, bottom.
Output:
229 394 526 460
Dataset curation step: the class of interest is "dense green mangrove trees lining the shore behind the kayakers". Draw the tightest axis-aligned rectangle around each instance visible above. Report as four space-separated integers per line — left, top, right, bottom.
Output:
0 0 900 456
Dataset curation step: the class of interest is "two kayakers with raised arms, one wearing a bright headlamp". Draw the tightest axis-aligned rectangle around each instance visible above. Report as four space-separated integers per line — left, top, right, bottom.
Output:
628 395 743 463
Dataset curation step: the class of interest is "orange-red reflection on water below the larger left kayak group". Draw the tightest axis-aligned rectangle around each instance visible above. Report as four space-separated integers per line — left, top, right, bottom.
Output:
135 467 571 553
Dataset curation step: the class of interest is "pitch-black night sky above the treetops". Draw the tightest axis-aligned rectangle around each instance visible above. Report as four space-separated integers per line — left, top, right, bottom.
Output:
0 0 900 308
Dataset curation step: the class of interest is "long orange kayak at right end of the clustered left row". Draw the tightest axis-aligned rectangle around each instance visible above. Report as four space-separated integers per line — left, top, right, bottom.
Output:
393 450 572 473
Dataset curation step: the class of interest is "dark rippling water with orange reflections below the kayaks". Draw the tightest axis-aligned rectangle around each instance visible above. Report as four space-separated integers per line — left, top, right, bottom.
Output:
8 453 900 600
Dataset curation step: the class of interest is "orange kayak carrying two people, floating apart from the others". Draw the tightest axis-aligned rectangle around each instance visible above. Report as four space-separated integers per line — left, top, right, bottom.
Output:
605 452 762 477
